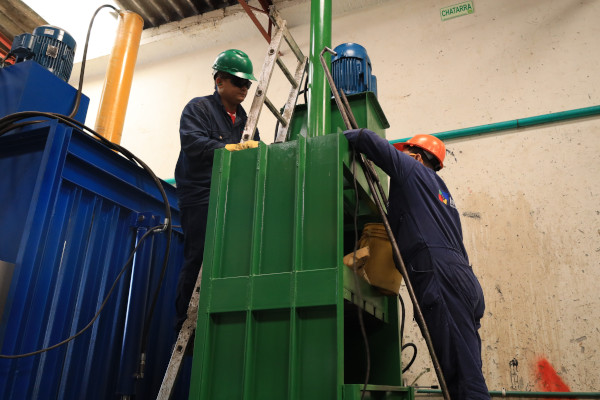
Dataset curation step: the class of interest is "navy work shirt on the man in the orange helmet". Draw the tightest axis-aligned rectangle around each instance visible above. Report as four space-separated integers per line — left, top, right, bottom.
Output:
344 129 469 268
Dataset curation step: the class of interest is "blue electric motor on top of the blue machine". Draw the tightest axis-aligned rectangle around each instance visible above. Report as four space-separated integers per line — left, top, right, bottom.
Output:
10 25 77 82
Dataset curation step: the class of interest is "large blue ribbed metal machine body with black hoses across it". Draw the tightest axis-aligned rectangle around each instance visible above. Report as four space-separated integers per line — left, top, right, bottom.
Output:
0 49 191 400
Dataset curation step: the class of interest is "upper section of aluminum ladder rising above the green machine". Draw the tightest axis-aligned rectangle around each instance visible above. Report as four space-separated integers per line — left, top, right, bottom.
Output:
241 7 308 143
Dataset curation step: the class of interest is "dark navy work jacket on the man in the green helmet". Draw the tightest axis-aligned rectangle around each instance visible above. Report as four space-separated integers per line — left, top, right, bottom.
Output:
175 91 260 207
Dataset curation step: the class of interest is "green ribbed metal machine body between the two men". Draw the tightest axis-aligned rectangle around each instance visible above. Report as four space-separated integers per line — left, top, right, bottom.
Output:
190 93 414 400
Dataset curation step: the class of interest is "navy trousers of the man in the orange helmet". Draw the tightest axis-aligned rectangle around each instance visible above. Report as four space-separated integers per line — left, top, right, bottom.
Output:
406 249 490 400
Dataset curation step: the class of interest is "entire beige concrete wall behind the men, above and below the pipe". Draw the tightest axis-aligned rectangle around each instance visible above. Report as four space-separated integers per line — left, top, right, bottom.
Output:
71 0 600 391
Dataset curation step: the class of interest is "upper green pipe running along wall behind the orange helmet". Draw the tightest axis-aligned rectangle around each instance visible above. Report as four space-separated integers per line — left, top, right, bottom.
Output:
390 106 600 144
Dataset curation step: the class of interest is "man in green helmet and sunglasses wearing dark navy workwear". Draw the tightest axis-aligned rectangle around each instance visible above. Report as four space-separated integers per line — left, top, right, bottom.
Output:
175 49 260 332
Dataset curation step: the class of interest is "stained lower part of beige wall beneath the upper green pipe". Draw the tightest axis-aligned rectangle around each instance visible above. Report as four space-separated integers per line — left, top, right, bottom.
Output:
404 118 600 391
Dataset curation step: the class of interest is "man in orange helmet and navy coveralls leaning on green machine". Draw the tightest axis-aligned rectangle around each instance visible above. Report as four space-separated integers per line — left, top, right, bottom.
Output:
344 129 490 400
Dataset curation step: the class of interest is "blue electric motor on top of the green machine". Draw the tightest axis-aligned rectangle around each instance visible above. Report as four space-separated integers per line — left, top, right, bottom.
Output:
331 43 377 96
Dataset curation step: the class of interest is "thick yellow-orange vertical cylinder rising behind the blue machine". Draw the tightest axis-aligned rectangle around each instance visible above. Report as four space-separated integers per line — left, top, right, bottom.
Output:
94 10 144 144
